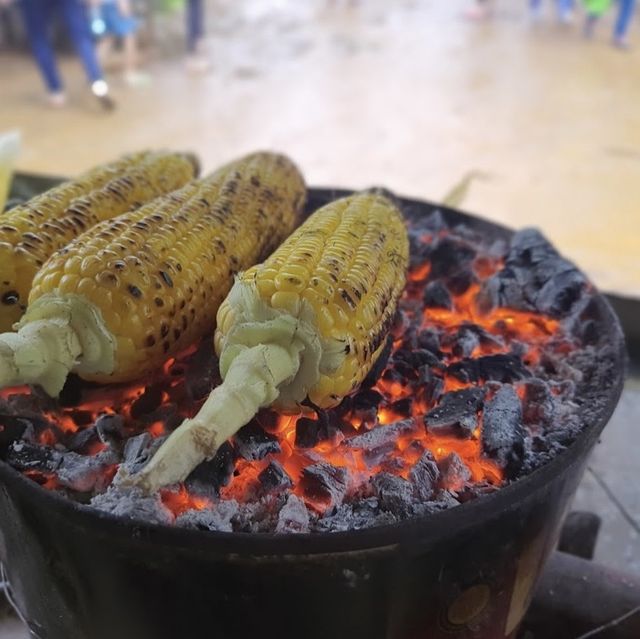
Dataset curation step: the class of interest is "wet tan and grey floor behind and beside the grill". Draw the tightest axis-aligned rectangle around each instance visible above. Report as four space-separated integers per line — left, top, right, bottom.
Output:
0 0 640 639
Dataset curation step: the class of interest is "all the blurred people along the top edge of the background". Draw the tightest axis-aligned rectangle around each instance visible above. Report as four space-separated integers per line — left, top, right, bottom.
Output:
0 0 636 109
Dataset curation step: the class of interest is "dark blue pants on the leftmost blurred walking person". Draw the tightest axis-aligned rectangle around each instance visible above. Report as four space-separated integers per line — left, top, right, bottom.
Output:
20 0 102 92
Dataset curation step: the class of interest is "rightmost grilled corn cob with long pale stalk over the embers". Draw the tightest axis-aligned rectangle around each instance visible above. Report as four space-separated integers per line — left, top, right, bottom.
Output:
134 193 409 491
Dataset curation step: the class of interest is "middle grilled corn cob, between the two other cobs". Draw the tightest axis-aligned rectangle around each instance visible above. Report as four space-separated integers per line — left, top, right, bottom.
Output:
0 153 306 395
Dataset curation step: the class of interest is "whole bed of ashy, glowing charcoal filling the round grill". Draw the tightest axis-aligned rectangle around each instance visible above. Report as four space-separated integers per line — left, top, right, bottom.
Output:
0 210 617 534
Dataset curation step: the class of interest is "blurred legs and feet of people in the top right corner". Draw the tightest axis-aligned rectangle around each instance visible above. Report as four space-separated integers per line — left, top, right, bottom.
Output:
469 0 637 49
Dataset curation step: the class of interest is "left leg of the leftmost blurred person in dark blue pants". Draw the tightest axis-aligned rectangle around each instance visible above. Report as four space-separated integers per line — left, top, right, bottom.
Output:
20 0 62 94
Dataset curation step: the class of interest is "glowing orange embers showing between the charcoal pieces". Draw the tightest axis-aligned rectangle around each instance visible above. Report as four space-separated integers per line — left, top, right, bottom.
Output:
10 226 573 516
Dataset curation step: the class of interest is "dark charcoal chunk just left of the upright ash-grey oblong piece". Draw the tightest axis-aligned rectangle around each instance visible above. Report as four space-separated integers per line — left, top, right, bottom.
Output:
424 387 485 437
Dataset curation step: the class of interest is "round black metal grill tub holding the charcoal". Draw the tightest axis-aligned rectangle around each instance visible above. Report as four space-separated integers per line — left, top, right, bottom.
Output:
0 189 625 639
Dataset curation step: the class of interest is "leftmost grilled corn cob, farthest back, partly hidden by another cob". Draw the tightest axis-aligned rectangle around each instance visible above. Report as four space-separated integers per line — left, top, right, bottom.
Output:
0 152 197 331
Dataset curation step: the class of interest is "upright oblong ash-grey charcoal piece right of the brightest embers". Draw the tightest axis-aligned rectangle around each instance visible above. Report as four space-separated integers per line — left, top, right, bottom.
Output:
482 386 524 476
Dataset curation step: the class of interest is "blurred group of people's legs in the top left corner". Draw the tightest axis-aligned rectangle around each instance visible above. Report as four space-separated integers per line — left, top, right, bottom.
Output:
0 0 208 109
